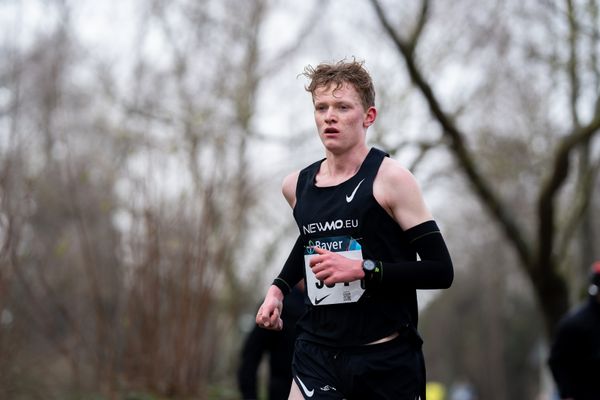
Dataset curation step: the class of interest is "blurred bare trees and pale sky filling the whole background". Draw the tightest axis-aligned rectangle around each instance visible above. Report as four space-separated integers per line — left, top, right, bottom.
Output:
0 0 600 400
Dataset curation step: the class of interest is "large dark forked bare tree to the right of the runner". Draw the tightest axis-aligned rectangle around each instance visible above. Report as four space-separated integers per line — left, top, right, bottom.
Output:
371 0 600 334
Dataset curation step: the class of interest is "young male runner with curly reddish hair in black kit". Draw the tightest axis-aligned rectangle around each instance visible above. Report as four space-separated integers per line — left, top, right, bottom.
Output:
256 61 453 400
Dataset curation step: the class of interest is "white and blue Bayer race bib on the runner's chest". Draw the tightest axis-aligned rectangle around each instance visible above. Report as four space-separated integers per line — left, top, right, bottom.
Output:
304 236 365 306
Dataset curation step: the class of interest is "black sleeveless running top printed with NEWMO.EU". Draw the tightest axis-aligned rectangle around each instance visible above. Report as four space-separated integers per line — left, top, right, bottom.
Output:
294 148 418 346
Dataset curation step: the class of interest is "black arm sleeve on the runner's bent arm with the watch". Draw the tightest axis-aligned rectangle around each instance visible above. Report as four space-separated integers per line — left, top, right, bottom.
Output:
380 221 454 289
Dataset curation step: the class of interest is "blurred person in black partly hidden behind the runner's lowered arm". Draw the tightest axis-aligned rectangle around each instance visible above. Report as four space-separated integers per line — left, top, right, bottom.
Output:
238 283 305 400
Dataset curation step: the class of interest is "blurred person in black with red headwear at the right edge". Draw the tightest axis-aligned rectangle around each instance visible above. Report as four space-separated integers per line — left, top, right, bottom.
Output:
549 261 600 400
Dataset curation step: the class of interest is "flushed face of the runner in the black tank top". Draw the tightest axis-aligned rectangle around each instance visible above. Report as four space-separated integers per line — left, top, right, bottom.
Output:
313 83 375 152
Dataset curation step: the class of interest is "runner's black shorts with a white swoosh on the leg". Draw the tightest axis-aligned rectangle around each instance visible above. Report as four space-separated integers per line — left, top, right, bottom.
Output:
292 329 425 400
